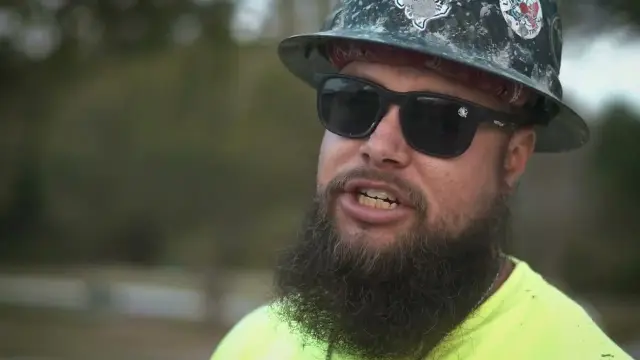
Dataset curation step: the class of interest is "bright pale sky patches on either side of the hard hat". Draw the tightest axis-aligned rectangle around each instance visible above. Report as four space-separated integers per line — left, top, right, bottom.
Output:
234 0 640 119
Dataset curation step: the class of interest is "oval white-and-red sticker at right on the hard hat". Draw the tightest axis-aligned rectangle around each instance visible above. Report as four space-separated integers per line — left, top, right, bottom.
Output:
500 0 543 39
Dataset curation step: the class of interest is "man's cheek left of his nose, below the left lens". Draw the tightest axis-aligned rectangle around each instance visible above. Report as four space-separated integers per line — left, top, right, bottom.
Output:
317 131 360 186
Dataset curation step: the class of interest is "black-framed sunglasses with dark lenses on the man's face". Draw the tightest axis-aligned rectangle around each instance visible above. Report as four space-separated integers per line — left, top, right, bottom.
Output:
317 74 519 158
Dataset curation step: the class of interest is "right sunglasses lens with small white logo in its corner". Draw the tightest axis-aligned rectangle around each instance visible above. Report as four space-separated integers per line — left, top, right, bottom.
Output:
400 97 477 157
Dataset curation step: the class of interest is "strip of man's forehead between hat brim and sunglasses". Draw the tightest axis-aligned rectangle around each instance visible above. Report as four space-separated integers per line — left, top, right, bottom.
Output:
341 61 509 111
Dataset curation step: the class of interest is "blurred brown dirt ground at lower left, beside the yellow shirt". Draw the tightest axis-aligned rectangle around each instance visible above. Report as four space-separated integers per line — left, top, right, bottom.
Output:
0 308 226 360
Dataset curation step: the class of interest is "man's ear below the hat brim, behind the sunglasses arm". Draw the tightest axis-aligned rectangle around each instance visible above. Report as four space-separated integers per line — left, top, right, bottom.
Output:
504 128 536 188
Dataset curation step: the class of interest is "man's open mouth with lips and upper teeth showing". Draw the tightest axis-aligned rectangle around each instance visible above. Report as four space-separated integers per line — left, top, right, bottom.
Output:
338 180 412 225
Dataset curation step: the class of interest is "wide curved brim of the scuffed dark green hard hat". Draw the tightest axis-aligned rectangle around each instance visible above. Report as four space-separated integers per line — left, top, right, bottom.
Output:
278 29 590 153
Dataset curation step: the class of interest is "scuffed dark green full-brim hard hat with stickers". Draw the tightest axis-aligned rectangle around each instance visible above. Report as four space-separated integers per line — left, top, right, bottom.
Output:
278 0 589 152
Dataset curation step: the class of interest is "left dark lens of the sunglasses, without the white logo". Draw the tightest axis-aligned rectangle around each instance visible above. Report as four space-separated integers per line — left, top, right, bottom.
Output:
318 78 380 138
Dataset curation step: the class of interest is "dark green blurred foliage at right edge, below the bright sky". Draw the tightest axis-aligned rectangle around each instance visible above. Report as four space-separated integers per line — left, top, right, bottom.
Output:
565 105 640 294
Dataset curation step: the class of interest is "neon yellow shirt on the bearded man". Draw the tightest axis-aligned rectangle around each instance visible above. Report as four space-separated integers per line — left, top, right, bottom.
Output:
211 259 632 360
